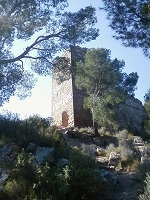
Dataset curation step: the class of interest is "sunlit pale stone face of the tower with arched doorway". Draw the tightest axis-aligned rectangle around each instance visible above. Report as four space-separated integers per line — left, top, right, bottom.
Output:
52 51 74 126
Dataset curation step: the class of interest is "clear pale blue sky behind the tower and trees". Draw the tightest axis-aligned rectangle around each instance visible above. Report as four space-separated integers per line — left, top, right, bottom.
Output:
0 0 150 118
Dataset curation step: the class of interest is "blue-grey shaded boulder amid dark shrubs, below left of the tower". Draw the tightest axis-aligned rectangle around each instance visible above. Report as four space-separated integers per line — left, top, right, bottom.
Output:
35 146 54 165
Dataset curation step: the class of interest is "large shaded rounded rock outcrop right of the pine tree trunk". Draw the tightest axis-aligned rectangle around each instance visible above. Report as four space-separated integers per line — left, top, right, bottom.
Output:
115 97 147 134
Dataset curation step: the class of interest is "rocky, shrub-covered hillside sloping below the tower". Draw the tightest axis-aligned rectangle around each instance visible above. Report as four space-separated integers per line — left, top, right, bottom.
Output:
0 117 149 200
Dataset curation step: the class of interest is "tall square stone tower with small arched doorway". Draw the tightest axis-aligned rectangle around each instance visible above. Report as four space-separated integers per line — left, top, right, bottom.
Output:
51 46 92 127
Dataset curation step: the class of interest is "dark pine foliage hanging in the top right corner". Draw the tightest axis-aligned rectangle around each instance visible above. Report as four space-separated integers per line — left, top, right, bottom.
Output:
102 0 150 57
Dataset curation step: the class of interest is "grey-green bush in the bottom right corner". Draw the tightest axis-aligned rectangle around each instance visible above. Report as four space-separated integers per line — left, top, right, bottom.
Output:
139 173 150 200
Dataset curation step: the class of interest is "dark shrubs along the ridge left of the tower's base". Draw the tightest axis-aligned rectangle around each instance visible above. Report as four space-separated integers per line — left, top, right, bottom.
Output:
0 114 66 147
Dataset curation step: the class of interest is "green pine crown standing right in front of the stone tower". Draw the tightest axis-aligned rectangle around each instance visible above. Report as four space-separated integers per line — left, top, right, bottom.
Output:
75 48 138 130
